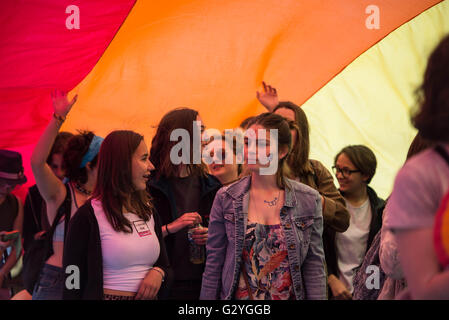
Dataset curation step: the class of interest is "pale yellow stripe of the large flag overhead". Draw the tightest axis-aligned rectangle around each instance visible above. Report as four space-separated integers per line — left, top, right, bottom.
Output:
300 0 449 198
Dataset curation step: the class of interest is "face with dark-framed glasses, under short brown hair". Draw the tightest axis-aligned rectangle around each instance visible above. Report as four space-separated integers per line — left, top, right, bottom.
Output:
335 153 368 193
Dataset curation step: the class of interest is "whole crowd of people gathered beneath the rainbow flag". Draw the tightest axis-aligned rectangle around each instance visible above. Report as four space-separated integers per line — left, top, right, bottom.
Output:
0 33 449 301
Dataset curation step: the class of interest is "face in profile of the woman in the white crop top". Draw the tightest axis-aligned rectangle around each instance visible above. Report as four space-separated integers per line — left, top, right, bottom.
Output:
131 140 154 191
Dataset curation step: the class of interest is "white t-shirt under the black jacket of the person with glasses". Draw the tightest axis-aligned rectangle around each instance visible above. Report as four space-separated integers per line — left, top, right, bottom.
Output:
335 199 372 293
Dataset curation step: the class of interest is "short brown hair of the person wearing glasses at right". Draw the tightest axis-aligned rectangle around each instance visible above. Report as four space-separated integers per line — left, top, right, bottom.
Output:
334 145 377 184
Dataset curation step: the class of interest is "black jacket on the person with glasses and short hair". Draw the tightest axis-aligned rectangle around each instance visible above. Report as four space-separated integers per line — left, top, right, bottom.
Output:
323 186 385 278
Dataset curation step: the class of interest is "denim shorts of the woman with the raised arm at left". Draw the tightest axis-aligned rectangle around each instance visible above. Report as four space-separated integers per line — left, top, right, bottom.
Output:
32 264 64 300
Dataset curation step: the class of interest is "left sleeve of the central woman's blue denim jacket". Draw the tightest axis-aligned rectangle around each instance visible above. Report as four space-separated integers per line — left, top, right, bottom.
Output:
200 188 228 300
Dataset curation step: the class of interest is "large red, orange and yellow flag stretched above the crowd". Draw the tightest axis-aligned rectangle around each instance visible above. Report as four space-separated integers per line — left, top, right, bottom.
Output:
0 0 449 197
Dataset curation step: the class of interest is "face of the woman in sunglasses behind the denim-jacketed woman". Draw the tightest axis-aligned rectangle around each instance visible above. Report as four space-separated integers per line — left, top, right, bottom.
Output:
204 139 238 183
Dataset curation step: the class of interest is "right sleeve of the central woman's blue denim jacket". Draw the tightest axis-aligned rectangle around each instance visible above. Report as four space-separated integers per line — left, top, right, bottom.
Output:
302 195 327 300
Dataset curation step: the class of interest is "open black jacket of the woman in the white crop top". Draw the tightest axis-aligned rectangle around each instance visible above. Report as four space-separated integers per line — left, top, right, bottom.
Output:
63 200 172 300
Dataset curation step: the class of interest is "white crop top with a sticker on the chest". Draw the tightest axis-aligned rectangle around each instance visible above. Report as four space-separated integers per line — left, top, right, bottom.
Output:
92 199 160 292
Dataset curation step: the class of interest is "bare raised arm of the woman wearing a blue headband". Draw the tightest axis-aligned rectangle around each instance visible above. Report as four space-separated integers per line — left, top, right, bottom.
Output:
31 90 77 210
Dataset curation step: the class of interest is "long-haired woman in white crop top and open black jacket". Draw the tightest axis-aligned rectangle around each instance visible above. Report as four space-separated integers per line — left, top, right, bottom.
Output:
64 131 168 300
